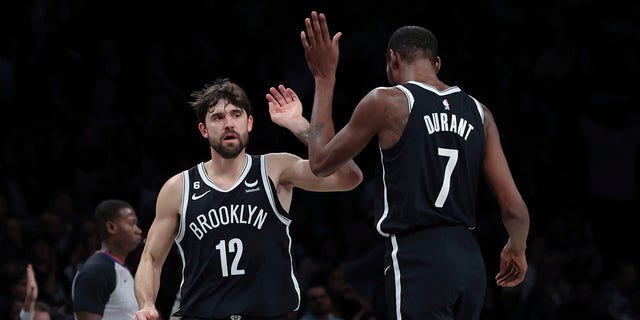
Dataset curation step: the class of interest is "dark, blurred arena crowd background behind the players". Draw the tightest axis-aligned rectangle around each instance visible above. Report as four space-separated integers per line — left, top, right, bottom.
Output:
0 0 640 319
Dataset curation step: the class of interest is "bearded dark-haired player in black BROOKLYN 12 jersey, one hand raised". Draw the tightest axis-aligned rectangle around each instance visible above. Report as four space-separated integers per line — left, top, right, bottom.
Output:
134 78 362 320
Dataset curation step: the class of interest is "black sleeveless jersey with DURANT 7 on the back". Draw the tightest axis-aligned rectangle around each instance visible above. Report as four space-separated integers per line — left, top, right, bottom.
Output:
375 81 485 236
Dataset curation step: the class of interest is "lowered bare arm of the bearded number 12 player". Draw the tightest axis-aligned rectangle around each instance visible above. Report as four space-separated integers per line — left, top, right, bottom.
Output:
134 174 183 320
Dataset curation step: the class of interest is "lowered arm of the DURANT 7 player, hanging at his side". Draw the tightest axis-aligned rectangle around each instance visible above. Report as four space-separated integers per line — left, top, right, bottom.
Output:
484 107 529 287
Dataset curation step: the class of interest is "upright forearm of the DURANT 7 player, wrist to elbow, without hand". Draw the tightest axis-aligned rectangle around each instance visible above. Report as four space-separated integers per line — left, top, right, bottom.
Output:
309 78 338 176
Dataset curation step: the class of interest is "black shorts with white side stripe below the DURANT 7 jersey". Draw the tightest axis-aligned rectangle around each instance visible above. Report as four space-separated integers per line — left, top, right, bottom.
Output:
385 226 487 320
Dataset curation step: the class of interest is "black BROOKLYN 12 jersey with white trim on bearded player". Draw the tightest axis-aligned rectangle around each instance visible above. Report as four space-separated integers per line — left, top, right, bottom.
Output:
175 155 300 319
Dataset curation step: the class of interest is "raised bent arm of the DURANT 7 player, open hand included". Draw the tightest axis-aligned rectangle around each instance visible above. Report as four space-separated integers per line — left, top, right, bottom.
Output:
300 11 384 177
